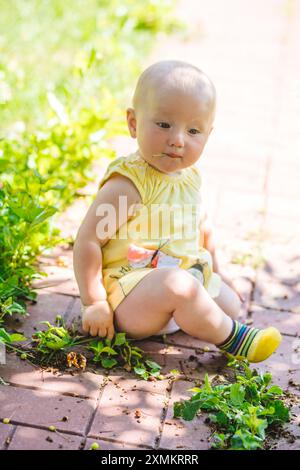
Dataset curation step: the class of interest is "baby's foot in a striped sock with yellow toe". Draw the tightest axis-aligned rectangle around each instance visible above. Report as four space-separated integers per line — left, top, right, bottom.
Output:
217 320 282 362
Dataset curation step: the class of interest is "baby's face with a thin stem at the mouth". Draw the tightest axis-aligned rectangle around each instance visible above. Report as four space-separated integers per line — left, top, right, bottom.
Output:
128 88 212 174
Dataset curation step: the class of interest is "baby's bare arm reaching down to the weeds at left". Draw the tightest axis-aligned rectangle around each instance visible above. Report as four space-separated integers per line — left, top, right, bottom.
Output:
73 174 140 339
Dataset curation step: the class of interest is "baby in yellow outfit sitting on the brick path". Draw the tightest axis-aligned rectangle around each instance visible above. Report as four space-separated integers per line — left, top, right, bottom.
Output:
74 60 281 362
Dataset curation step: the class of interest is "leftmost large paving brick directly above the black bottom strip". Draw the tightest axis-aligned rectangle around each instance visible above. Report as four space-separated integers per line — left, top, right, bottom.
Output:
9 426 83 450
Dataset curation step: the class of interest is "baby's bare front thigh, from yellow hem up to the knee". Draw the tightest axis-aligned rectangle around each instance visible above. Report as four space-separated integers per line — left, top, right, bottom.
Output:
114 268 195 339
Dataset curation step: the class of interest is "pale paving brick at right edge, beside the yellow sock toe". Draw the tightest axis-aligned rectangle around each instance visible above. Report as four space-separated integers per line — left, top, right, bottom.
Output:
251 305 300 336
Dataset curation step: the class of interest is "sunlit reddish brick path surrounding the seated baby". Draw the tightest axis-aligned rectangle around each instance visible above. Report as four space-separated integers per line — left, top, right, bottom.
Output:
0 0 300 449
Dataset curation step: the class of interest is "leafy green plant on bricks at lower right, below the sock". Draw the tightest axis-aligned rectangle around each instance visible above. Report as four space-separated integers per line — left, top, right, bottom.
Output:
174 359 289 450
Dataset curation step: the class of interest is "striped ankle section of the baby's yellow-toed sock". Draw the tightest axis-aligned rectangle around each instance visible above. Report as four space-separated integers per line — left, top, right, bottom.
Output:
217 320 260 358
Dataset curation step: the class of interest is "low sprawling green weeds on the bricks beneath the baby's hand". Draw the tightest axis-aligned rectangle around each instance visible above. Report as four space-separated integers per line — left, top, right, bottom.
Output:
13 315 162 380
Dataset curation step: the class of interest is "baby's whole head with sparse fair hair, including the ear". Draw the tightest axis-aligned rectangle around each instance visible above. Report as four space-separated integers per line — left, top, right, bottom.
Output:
127 60 216 174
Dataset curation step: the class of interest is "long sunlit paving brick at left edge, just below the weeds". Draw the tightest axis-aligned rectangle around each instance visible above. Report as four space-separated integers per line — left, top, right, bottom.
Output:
0 354 104 399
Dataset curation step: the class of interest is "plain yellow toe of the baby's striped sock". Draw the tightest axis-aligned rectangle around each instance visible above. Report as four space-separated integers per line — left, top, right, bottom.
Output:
247 326 282 362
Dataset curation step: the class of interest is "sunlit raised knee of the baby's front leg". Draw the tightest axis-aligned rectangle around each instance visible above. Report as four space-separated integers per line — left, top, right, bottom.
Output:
164 268 199 299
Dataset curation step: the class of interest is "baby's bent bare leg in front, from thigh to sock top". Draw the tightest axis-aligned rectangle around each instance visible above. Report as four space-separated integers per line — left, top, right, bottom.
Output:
115 268 232 344
